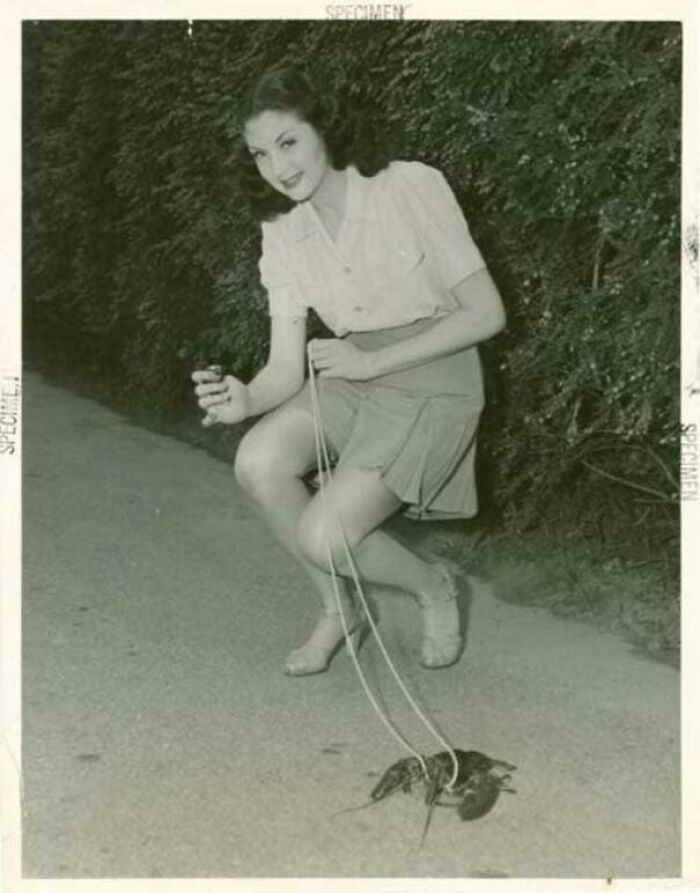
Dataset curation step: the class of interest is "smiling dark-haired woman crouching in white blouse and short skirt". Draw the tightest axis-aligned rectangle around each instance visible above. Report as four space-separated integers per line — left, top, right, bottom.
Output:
193 68 504 676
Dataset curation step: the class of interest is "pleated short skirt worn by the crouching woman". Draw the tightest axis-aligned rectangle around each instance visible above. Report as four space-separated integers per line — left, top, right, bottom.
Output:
299 319 484 520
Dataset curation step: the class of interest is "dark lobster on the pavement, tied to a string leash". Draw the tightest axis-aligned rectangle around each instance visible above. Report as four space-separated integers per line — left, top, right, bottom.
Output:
336 749 516 844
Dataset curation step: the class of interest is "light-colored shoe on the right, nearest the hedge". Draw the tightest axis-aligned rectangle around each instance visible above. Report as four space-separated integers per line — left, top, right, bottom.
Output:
418 562 464 670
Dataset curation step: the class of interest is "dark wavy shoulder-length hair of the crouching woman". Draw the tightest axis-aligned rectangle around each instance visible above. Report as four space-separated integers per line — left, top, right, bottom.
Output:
235 65 390 221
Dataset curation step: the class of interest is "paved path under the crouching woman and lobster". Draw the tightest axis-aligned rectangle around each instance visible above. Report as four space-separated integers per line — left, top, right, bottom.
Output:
23 376 680 877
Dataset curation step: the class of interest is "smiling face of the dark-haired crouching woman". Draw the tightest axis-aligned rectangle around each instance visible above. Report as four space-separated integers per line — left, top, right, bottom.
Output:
243 111 330 202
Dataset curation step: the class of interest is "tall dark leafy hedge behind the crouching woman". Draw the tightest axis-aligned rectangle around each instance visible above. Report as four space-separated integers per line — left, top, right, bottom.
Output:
24 21 682 548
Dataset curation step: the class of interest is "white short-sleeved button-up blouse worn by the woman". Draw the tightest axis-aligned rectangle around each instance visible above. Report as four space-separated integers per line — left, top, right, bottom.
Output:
259 161 486 337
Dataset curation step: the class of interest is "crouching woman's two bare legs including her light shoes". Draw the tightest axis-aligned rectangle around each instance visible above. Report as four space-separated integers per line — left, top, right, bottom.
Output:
236 392 461 674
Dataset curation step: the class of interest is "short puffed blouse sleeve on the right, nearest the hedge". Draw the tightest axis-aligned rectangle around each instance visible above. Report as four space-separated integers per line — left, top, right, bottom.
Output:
395 161 486 288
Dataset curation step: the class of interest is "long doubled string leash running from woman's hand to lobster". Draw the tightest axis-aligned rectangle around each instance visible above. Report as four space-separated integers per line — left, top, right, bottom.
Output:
307 354 459 791
